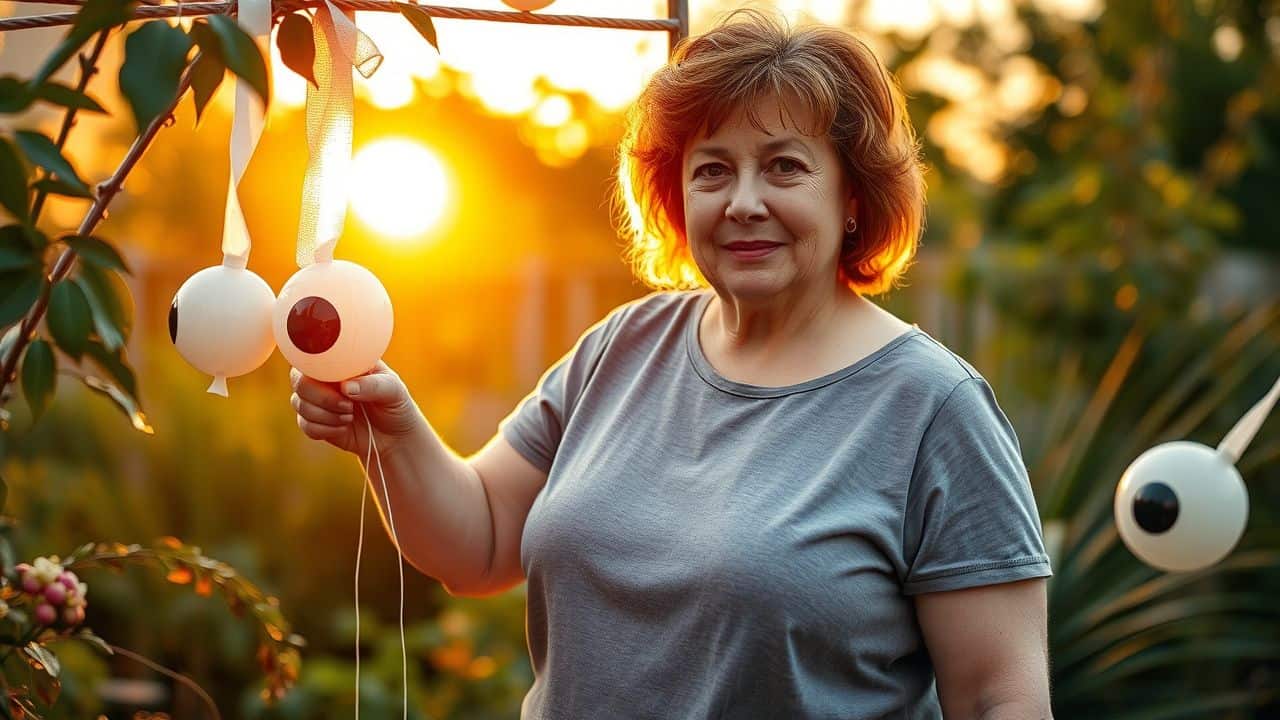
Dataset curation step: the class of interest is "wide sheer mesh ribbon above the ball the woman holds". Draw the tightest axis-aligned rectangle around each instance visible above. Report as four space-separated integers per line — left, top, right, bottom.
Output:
297 0 383 268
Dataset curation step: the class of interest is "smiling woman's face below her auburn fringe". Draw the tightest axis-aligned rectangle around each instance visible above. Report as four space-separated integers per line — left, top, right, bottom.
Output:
684 94 856 302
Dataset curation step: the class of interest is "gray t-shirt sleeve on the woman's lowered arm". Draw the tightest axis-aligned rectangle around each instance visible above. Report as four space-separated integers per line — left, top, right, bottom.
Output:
902 377 1052 594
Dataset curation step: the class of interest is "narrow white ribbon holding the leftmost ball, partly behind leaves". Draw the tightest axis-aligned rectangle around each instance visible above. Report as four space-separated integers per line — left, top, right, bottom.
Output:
223 0 271 268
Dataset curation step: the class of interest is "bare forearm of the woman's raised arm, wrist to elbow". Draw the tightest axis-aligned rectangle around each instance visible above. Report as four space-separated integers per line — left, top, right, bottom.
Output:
360 418 493 592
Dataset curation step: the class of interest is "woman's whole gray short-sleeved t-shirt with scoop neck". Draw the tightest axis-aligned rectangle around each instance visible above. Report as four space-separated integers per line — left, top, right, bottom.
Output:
502 291 1051 720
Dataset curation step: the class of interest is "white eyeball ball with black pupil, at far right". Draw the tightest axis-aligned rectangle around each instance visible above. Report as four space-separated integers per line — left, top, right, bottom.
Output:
1114 441 1249 573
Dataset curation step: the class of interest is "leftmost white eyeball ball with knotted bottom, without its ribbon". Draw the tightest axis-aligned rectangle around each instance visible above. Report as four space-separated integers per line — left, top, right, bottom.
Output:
169 259 275 397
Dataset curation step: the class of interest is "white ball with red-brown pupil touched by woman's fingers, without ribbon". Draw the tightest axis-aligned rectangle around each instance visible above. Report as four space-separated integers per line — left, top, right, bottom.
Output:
271 260 393 382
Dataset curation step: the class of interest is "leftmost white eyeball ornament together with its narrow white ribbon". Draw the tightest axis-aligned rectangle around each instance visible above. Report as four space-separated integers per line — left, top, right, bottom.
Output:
169 0 275 397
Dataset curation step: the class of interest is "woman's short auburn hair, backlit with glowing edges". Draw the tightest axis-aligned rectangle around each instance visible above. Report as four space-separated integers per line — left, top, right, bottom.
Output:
614 9 924 295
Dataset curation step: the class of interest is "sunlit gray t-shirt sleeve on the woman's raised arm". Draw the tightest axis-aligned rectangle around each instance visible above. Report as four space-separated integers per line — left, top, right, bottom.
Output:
498 305 627 473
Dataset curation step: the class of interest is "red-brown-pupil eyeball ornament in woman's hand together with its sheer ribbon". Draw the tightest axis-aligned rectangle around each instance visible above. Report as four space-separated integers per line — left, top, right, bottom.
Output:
279 1 393 382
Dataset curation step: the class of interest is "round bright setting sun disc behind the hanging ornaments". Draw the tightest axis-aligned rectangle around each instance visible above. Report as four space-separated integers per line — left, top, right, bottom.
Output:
351 138 449 238
